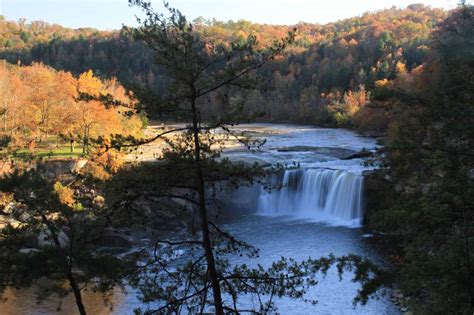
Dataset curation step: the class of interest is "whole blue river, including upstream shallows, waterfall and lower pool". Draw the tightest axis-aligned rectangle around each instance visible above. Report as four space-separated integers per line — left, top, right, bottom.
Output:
0 124 399 315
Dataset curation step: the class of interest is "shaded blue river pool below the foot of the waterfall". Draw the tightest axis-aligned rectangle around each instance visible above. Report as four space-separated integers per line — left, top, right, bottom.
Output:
0 215 399 315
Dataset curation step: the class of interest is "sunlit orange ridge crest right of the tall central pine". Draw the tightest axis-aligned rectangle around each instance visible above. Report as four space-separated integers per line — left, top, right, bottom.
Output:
194 4 446 51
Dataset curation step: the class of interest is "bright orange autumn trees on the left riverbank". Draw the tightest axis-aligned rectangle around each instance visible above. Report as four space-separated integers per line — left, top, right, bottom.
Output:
0 62 142 152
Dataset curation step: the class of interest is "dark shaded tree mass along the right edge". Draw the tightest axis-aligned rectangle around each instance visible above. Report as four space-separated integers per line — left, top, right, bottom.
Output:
371 6 474 314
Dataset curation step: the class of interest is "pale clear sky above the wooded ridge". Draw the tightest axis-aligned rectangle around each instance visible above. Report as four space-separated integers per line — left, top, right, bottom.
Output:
0 0 459 30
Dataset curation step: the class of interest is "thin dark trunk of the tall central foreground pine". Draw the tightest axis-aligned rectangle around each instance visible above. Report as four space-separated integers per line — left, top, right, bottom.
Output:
192 99 224 315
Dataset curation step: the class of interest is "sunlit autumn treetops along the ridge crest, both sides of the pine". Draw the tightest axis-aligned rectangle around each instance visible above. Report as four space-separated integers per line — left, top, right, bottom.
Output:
0 4 446 51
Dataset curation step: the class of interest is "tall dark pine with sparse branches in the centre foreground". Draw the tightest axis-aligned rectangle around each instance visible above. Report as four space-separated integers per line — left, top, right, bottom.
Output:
112 0 381 314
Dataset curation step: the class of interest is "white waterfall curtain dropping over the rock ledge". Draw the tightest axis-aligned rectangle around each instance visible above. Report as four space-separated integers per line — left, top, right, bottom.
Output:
258 169 364 226
